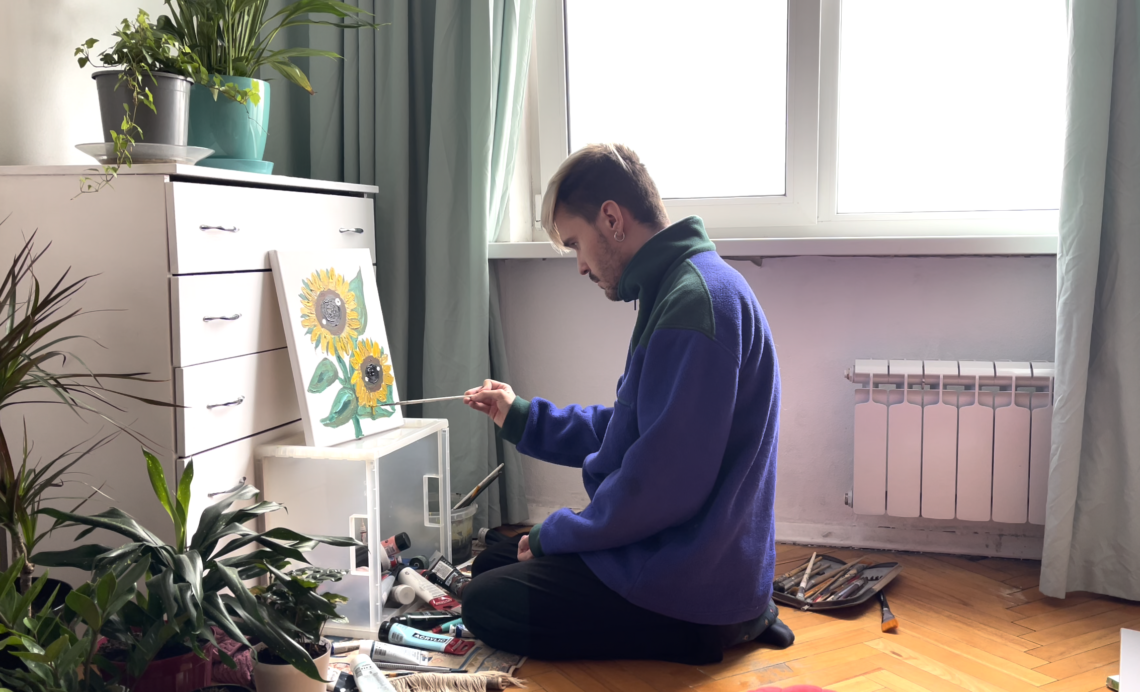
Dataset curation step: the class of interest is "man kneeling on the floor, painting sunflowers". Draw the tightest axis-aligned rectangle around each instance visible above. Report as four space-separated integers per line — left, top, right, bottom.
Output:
463 145 793 663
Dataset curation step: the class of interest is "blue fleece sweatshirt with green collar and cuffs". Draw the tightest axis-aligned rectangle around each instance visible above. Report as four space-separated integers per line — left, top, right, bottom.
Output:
503 217 780 625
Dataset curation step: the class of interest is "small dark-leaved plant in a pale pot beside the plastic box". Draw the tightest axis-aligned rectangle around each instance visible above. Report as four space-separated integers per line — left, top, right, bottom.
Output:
251 565 348 692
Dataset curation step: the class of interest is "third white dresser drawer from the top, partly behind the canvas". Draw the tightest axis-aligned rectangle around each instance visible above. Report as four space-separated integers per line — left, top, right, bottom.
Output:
174 349 301 456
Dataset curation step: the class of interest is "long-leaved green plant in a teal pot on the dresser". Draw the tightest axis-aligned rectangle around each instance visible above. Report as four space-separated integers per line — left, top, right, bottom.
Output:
157 0 381 173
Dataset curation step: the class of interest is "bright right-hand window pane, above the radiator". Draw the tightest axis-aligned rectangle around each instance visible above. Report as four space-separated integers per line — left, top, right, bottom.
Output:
837 0 1067 213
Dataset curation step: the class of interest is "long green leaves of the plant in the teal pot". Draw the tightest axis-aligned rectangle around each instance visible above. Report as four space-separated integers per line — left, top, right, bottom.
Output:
157 0 383 93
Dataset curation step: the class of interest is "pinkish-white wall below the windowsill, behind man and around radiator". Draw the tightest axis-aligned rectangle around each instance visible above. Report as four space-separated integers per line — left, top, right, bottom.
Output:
499 257 1056 556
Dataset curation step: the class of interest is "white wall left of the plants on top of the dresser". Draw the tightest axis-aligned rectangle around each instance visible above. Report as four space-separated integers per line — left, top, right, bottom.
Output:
0 0 163 165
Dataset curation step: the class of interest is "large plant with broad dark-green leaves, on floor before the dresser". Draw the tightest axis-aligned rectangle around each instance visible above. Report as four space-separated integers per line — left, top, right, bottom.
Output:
34 451 364 679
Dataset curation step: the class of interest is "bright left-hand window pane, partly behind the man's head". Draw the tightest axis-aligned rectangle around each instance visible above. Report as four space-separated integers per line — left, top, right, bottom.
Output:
565 0 788 197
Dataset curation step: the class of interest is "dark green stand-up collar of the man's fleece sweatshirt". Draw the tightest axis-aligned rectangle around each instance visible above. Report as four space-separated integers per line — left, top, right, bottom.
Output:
618 217 716 309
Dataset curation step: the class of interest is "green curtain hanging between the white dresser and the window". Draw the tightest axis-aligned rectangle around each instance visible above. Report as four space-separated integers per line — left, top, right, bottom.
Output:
263 0 535 526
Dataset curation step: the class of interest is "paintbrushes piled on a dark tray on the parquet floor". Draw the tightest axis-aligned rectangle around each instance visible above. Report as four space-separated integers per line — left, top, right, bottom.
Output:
772 553 903 610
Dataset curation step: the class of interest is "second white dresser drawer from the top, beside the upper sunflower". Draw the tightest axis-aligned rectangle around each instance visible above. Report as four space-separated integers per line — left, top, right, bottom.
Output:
170 271 286 367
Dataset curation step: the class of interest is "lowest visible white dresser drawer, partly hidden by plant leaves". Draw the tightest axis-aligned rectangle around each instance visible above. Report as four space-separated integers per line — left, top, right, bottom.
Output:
178 421 304 536
